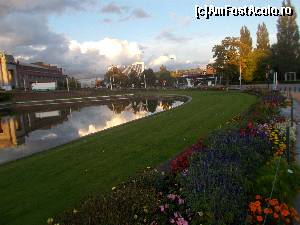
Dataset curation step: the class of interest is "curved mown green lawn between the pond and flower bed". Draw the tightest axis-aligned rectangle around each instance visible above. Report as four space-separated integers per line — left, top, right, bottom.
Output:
0 91 256 225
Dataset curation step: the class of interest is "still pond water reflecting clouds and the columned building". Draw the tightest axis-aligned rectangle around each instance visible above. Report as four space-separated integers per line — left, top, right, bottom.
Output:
0 97 183 164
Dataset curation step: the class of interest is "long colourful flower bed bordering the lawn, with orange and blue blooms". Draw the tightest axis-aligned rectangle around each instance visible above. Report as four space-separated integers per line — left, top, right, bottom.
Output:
48 90 300 225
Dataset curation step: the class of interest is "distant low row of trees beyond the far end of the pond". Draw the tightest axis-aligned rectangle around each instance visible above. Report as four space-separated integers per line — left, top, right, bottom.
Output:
104 66 176 88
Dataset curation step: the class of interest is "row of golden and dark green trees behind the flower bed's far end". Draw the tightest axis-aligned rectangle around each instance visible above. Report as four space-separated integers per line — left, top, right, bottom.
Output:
212 0 300 82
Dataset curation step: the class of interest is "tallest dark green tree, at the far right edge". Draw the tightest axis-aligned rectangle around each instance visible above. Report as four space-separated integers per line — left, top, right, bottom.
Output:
274 0 300 77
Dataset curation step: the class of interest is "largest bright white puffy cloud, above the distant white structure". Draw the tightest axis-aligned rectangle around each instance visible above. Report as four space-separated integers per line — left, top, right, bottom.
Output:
66 38 141 77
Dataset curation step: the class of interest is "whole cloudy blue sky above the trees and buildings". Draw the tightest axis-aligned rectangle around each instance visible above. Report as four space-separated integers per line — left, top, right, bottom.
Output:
0 0 300 78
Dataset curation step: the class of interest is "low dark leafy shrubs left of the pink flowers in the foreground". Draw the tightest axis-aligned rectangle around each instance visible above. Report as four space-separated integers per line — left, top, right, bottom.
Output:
53 174 161 225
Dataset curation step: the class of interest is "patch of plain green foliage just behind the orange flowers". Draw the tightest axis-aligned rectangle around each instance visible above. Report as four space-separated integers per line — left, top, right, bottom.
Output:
252 158 300 204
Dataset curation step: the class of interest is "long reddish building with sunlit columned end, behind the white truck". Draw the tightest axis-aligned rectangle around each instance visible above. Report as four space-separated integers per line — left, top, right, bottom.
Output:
0 52 67 90
